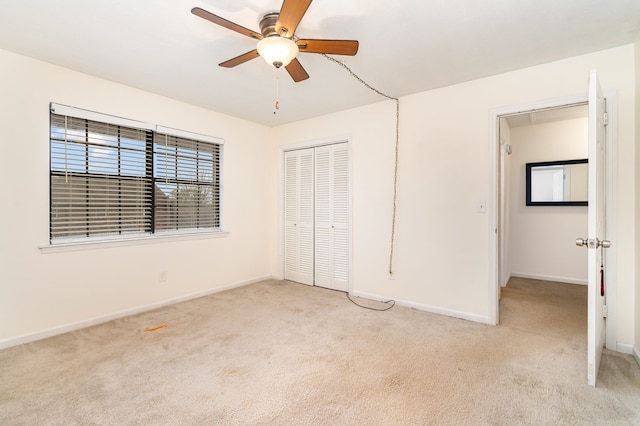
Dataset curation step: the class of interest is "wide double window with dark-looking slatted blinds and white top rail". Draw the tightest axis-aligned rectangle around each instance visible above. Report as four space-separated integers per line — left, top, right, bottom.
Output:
50 104 222 243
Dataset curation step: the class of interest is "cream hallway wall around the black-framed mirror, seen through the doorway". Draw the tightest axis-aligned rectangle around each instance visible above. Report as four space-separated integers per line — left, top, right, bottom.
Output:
509 118 589 284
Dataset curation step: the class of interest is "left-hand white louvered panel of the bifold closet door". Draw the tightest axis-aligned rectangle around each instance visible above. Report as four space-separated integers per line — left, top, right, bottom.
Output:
284 148 314 285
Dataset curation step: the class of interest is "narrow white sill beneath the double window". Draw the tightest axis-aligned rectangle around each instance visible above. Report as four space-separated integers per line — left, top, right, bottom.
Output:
38 231 229 254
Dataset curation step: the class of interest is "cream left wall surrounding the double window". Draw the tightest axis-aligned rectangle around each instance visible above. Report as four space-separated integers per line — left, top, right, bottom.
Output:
0 51 277 346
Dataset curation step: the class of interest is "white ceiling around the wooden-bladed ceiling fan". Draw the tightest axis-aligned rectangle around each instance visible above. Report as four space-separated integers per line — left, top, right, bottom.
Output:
0 0 640 126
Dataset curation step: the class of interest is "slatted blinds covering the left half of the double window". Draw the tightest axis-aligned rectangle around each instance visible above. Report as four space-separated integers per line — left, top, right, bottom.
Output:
50 114 152 240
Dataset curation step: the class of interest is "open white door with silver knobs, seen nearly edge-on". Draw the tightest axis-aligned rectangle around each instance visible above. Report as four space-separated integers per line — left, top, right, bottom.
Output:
583 70 609 386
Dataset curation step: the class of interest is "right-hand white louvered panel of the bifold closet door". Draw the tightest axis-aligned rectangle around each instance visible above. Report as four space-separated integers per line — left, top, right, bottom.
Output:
315 143 349 291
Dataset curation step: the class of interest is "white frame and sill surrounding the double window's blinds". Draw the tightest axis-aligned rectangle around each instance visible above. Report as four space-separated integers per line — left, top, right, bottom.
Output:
39 102 228 252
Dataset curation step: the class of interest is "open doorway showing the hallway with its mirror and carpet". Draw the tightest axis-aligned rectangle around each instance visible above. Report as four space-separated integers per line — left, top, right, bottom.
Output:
499 103 589 368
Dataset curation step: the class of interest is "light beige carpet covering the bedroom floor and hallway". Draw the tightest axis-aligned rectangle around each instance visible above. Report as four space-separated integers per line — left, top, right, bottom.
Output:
0 279 640 425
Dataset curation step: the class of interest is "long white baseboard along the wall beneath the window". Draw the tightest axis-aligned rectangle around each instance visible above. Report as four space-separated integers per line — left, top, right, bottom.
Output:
0 275 273 349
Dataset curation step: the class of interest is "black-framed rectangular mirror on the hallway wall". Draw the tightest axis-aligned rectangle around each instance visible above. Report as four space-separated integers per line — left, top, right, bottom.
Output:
526 158 589 206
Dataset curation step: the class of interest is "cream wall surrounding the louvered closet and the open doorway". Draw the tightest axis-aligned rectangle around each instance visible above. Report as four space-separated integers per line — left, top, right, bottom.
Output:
274 45 635 343
